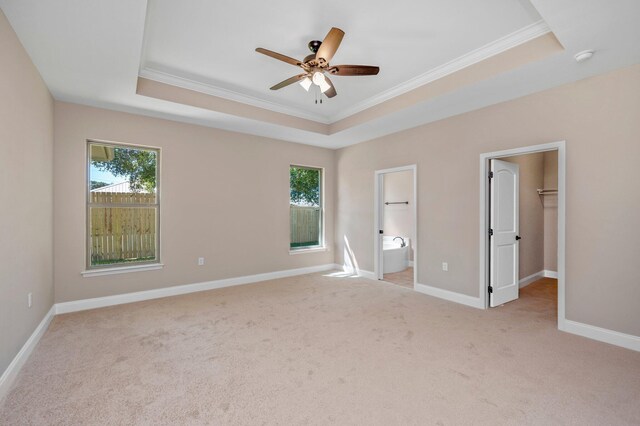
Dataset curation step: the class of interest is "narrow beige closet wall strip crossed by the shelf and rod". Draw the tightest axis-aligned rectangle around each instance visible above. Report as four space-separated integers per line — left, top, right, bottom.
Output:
541 151 558 271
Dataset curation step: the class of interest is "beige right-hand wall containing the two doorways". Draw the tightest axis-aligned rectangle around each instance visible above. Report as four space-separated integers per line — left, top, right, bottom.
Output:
336 65 640 335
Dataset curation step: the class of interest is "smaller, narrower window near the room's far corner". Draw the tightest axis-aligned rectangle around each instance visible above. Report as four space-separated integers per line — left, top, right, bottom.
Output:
289 165 324 250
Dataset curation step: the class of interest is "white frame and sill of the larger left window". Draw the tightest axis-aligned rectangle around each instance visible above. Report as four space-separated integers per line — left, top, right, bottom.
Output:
81 139 164 277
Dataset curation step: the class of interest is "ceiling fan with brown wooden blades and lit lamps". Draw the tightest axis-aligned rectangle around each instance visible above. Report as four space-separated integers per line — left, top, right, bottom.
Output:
256 27 380 102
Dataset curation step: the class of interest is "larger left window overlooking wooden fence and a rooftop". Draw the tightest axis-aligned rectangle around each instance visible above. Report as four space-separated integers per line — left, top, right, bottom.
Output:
87 141 160 269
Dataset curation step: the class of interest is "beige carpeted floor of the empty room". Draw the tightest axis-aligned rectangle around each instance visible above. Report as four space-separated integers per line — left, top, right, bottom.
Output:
0 274 640 425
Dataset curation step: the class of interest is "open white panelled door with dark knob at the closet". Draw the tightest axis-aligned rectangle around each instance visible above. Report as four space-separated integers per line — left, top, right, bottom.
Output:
489 160 520 307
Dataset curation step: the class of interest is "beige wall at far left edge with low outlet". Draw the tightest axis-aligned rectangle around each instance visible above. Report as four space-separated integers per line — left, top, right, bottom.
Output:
0 11 53 375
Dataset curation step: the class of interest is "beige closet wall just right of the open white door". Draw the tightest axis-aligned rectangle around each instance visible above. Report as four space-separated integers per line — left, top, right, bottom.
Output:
501 153 545 279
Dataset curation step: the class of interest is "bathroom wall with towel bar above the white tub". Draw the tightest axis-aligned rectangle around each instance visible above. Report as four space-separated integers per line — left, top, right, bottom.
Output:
383 170 414 260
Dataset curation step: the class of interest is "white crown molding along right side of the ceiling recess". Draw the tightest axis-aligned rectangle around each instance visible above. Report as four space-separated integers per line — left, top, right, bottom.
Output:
329 20 551 123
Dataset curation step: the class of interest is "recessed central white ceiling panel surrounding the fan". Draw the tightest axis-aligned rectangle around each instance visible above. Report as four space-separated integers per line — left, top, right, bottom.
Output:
141 0 541 122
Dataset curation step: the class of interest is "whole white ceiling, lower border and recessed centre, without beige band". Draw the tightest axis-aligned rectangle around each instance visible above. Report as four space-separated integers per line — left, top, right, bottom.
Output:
0 0 640 148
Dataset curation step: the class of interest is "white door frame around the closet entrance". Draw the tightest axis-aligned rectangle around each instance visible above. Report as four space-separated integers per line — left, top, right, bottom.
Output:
479 141 566 330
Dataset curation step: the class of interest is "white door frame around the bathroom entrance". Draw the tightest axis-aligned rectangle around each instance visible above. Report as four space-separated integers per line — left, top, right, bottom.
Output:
373 164 418 289
